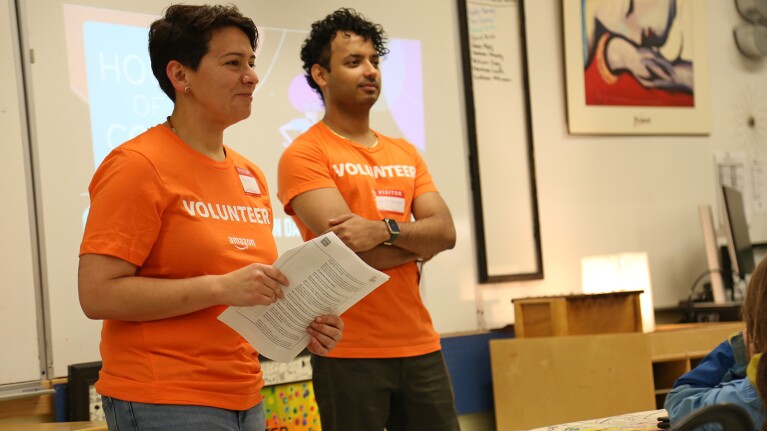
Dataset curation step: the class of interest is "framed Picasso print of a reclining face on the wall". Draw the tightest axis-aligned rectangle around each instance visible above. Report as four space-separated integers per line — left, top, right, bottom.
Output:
562 0 710 135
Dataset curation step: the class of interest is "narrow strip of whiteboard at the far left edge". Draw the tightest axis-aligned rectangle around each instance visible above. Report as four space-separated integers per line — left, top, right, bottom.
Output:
0 0 43 384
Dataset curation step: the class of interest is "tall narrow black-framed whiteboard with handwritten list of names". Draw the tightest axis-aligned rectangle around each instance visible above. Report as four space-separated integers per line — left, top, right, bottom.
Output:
457 0 543 283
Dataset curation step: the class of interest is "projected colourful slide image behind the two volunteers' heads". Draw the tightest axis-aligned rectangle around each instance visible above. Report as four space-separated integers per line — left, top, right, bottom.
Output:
63 4 426 241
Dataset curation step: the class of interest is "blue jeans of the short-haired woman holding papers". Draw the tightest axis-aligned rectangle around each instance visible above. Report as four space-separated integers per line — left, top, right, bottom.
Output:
101 397 266 431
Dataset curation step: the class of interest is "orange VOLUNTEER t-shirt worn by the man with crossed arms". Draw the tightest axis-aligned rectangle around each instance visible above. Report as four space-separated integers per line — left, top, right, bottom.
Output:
277 122 440 358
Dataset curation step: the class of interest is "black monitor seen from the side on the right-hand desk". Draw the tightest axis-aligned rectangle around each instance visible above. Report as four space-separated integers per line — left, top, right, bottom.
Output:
722 186 756 278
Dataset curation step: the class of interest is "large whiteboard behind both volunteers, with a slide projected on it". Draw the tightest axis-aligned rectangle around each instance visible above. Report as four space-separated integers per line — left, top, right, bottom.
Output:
21 0 477 376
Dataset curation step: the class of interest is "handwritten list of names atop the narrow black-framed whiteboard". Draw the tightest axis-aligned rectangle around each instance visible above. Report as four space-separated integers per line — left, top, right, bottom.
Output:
467 0 517 82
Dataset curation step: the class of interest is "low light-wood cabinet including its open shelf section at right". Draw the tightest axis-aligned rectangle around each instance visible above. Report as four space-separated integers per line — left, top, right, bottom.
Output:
490 323 743 430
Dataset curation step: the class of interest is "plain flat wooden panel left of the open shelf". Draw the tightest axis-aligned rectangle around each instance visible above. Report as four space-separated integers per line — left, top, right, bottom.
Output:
490 333 655 431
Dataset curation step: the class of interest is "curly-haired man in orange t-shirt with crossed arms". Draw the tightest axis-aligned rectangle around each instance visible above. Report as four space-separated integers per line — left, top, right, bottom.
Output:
278 9 459 431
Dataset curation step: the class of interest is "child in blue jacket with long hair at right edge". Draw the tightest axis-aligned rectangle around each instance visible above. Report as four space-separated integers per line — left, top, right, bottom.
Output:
664 259 767 430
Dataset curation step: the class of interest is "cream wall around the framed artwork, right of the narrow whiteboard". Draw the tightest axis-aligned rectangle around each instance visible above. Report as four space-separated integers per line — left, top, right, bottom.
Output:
481 0 767 327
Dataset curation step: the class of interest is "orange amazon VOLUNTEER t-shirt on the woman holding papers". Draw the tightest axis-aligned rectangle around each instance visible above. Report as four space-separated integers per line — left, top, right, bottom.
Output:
80 126 277 410
